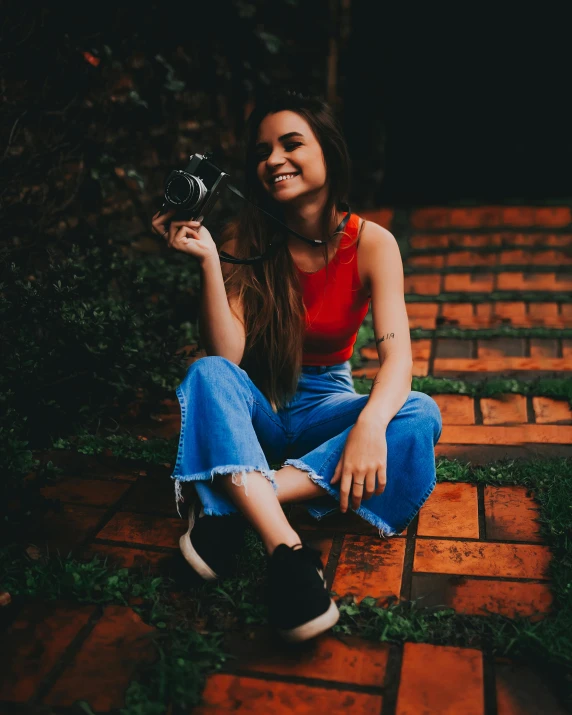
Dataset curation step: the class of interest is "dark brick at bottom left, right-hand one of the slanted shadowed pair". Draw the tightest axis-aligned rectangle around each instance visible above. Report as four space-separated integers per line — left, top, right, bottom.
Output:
44 606 156 712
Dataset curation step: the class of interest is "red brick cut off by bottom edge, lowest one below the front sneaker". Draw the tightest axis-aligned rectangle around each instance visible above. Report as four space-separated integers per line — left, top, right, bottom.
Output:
193 674 382 715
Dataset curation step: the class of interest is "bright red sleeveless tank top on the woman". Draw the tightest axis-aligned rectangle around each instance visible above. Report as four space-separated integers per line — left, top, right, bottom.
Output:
296 214 370 365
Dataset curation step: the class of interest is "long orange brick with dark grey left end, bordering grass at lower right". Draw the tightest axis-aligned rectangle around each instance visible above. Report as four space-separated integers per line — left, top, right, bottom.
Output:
411 573 552 620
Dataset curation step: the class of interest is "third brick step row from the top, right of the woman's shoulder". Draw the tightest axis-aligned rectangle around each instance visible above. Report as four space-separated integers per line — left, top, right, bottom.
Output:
405 247 572 268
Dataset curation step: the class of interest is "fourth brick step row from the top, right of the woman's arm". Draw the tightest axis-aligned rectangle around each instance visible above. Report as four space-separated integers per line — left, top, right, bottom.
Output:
405 272 572 295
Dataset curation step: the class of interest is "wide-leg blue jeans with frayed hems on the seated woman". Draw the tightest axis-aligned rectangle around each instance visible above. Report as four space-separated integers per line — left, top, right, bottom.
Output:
171 356 442 536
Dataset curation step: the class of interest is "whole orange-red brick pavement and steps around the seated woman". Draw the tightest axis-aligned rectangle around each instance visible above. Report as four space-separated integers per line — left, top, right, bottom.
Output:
0 207 572 715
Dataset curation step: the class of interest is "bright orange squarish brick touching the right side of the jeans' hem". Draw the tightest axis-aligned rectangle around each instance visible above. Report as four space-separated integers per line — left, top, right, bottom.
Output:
417 482 479 539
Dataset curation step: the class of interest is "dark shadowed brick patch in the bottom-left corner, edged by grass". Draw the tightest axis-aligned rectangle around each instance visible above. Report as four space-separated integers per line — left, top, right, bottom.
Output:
0 601 157 712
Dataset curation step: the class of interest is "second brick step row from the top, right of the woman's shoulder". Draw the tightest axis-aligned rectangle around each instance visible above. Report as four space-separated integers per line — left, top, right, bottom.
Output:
409 233 572 251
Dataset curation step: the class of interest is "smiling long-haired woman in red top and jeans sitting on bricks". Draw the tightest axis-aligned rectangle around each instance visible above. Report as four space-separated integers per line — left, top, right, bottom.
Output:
153 93 441 641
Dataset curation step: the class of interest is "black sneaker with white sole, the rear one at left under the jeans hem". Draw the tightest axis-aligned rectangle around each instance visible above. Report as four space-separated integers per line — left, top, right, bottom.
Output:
179 495 248 581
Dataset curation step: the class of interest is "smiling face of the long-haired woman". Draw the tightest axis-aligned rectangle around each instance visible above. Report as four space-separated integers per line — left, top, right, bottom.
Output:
255 111 327 203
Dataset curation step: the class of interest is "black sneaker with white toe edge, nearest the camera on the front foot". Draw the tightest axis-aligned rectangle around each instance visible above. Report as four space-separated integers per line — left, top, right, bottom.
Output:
268 544 340 642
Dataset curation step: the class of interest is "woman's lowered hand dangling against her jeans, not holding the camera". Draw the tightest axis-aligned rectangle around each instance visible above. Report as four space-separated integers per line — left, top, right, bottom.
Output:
330 422 387 513
